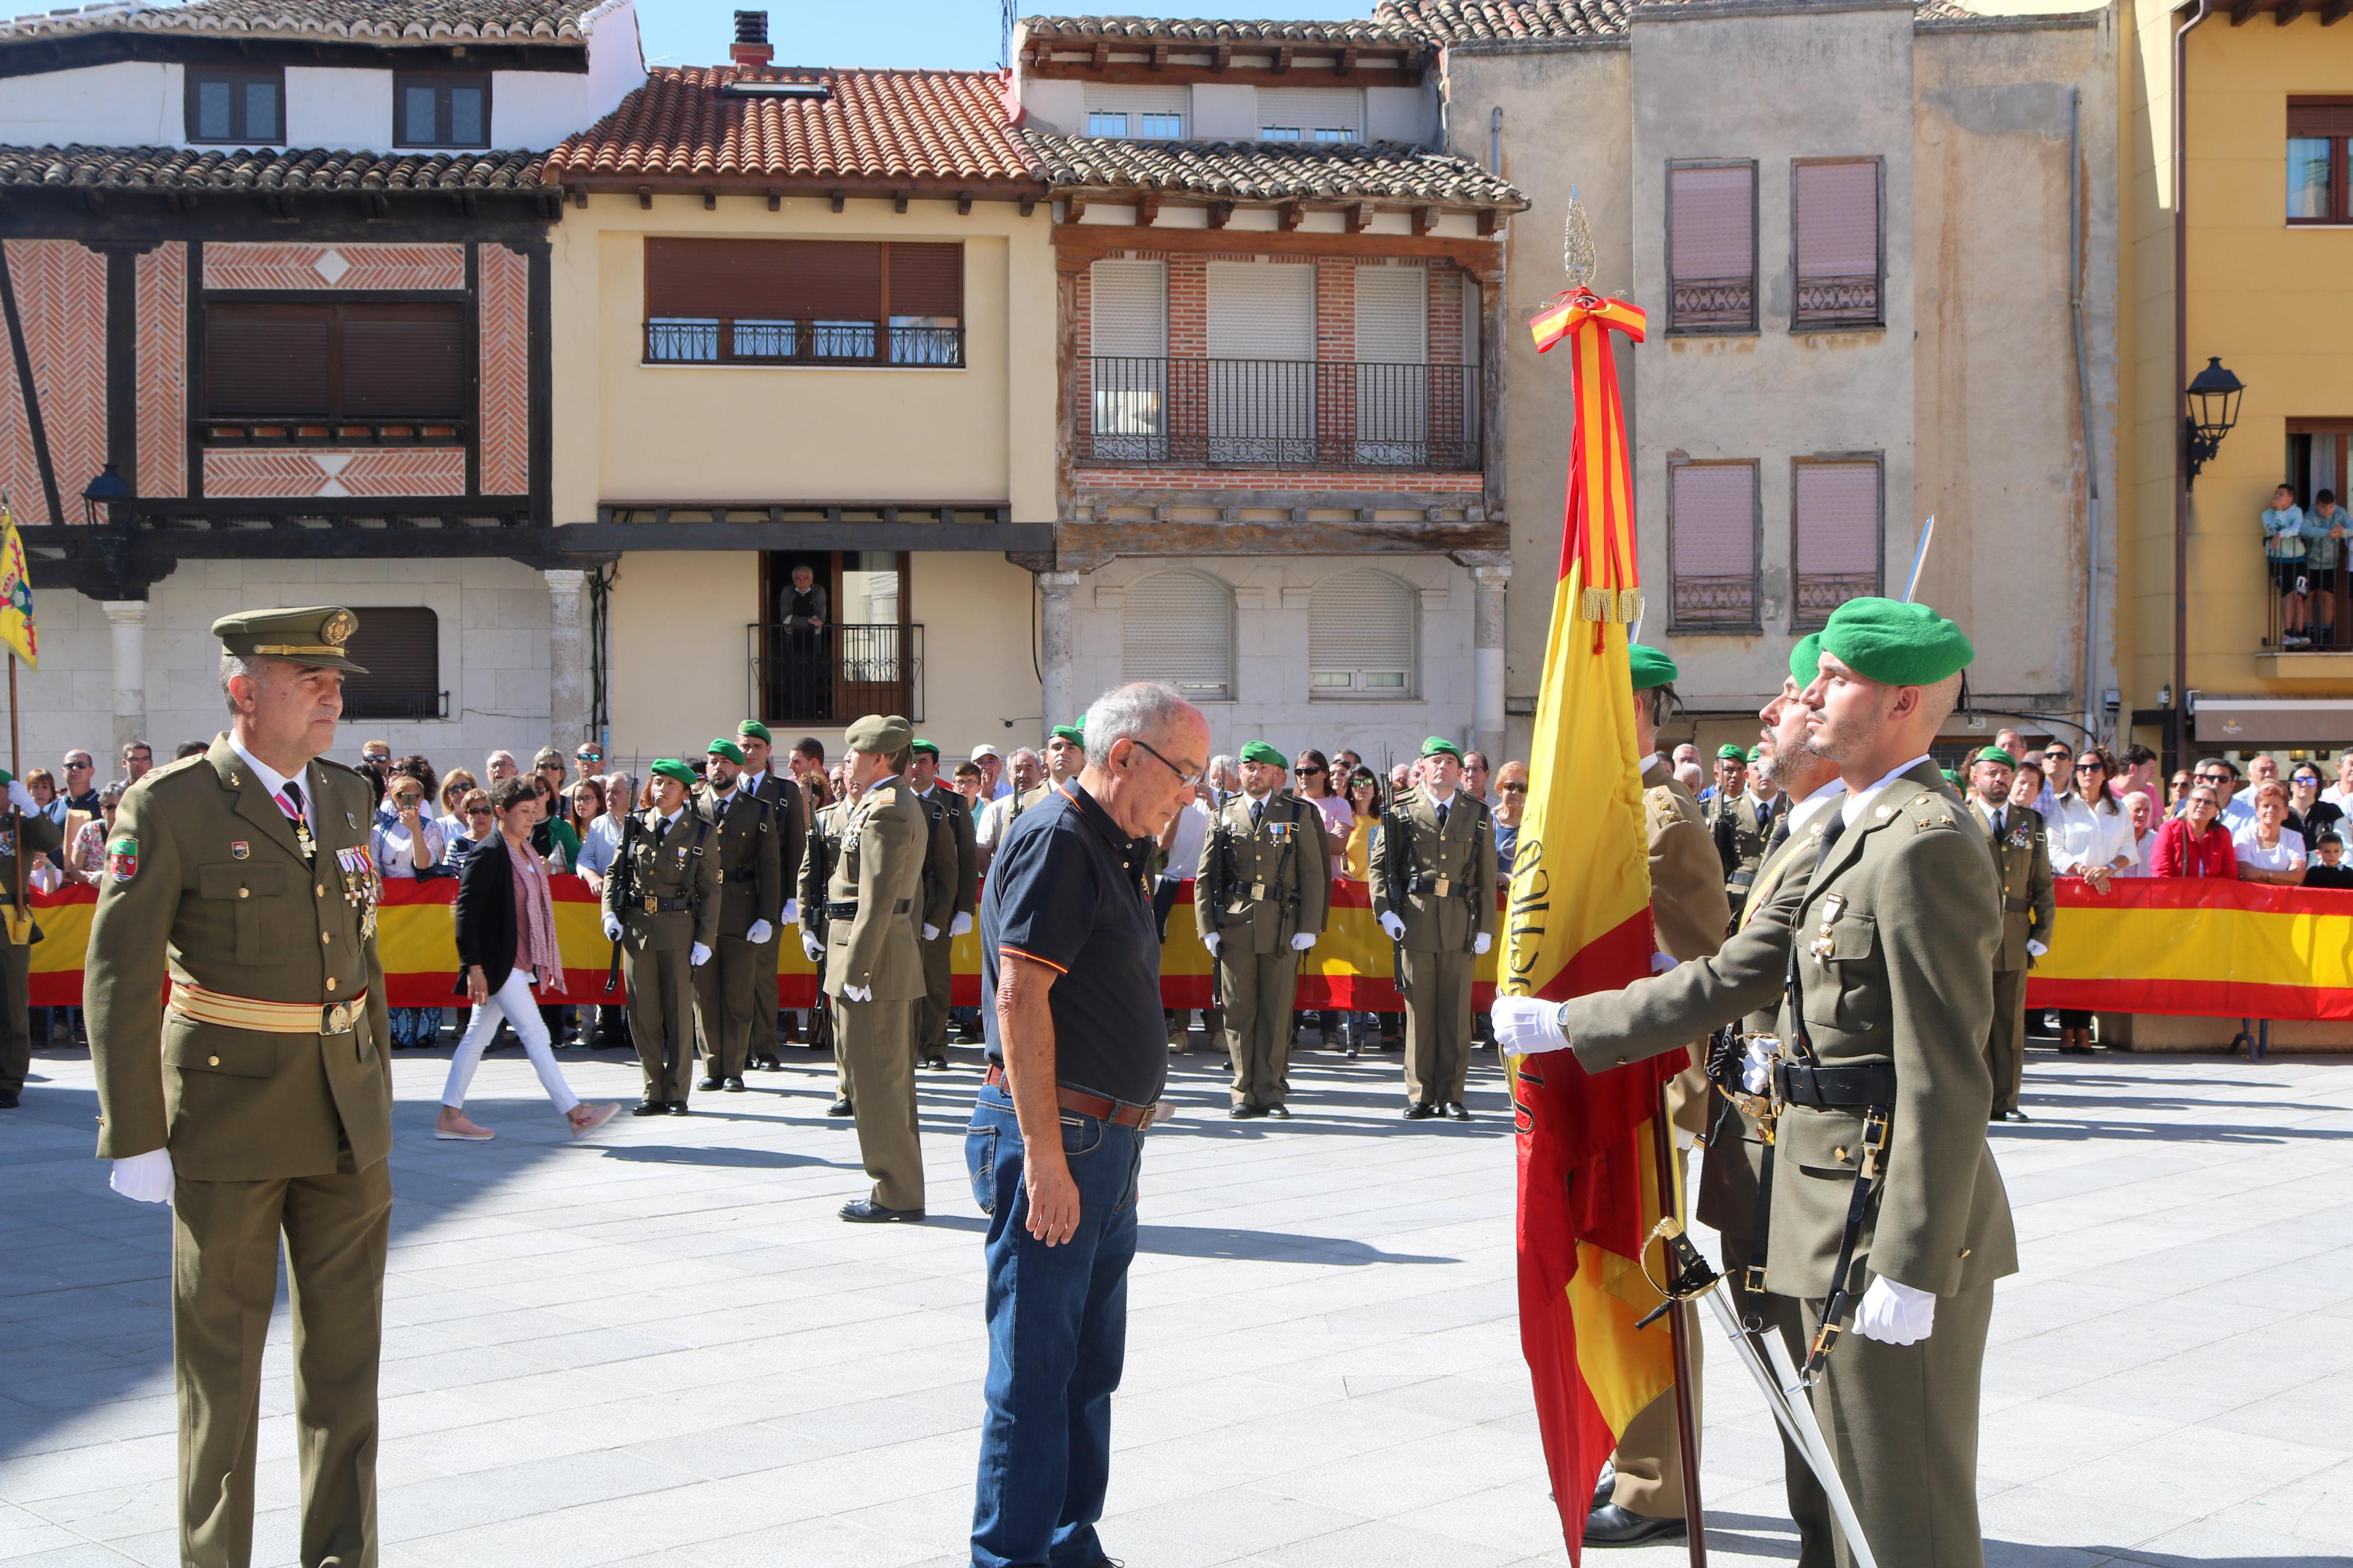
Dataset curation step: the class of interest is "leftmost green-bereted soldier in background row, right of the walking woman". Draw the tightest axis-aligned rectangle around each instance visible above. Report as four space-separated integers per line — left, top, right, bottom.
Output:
605 757 720 1117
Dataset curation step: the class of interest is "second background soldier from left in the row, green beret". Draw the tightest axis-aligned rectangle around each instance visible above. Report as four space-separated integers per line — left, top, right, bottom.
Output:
694 736 783 1093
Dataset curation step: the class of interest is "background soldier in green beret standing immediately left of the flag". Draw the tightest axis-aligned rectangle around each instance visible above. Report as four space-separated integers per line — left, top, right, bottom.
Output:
1372 736 1496 1121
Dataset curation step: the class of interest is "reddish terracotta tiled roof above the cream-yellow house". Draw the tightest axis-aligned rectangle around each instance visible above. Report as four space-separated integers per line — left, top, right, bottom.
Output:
546 66 1042 190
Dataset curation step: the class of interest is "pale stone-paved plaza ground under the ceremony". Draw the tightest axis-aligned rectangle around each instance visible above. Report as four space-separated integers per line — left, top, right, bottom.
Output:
0 1029 2353 1568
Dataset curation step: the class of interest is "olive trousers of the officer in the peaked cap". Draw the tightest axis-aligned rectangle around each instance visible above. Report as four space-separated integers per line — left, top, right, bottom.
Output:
172 1150 393 1568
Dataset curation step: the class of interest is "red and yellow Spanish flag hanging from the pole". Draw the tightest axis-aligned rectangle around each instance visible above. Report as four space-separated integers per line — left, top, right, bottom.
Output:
1496 289 1685 1563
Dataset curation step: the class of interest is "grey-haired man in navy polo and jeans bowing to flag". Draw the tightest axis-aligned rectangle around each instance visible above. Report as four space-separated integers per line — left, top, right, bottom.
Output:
965 682 1209 1568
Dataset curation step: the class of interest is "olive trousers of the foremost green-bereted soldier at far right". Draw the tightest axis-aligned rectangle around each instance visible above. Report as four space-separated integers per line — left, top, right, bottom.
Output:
1802 1283 1993 1568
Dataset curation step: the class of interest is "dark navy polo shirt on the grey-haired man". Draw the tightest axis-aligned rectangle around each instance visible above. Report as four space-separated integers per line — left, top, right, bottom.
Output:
981 780 1169 1105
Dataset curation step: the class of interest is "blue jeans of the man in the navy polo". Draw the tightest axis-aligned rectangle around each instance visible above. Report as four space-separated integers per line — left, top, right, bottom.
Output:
965 1089 1144 1568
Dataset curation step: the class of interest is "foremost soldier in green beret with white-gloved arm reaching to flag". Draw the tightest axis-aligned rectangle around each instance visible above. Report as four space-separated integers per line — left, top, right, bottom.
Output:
1494 599 2017 1568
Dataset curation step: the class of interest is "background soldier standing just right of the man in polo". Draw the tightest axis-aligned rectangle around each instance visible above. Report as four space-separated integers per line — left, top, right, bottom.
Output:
1193 741 1332 1119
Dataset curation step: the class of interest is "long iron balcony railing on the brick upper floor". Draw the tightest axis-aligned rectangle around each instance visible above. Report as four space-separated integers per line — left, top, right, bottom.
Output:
1071 355 1485 472
